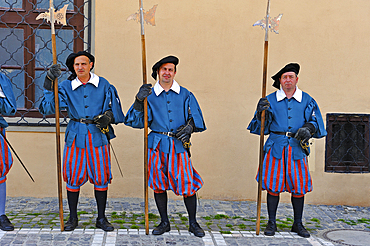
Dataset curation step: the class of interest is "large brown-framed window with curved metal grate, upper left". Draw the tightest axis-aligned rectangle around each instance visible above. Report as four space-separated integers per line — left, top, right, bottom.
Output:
0 0 91 126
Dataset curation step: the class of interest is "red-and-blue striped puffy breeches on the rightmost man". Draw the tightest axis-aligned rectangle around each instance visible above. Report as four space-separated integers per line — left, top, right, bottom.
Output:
256 145 312 197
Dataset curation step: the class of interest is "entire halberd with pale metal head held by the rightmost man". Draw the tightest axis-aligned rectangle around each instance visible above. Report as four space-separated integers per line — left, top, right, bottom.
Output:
253 0 283 235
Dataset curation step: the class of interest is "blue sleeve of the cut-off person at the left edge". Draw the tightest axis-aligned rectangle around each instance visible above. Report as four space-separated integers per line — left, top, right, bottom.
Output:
0 73 17 115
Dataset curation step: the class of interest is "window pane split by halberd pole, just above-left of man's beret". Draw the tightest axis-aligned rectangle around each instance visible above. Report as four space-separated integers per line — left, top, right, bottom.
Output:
35 29 73 68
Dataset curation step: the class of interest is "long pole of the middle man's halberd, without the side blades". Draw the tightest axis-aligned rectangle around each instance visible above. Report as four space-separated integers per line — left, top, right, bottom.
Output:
139 0 149 235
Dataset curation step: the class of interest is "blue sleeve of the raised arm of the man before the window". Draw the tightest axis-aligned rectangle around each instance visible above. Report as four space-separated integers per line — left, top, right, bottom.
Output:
39 85 67 115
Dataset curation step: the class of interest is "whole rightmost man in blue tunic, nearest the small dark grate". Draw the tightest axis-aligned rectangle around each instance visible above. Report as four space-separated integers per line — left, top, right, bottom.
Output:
248 63 326 237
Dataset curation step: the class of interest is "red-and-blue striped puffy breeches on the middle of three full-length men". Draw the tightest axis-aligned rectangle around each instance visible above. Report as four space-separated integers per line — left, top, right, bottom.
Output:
148 140 203 197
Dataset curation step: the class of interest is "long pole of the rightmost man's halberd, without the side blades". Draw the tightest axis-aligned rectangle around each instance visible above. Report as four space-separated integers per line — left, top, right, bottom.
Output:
256 0 270 235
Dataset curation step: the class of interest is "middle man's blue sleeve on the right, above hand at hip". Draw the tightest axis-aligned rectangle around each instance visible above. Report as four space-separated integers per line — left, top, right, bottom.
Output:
185 92 207 132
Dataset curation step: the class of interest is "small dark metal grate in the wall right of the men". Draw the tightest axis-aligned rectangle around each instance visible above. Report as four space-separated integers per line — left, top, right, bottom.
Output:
325 114 370 173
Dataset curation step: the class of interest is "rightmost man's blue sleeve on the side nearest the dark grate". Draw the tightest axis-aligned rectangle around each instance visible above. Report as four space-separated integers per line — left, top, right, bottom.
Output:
304 99 327 138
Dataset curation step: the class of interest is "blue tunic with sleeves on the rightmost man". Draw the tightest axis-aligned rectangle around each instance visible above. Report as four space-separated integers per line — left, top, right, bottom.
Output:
248 92 326 160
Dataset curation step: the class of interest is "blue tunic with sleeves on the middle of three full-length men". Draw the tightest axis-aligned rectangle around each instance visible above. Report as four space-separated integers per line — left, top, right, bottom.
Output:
125 86 206 154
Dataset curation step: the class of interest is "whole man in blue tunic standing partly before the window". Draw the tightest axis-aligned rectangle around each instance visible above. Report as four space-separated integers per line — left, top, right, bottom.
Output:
39 51 124 231
